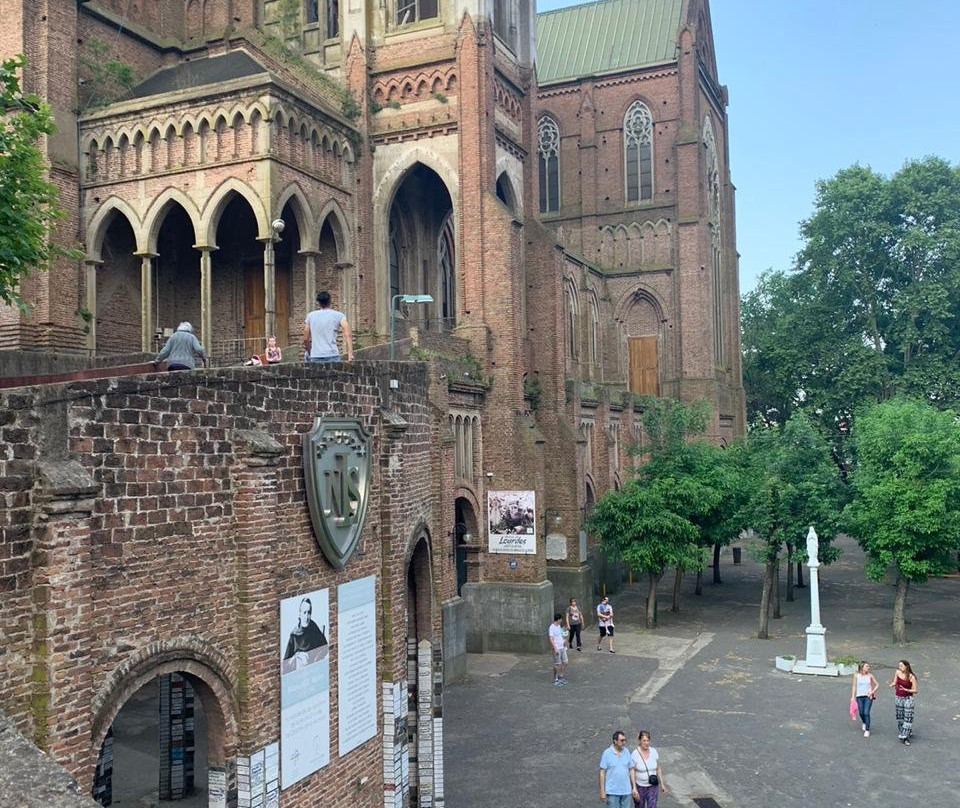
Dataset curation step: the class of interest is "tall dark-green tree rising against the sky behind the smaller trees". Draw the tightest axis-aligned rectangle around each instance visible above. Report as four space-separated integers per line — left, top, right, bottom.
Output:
742 157 960 443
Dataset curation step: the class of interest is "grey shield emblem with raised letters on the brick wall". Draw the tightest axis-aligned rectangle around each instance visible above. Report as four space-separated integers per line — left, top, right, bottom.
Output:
303 418 372 569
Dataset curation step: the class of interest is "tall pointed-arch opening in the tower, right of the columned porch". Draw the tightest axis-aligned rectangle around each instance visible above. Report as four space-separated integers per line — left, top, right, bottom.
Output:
387 163 457 335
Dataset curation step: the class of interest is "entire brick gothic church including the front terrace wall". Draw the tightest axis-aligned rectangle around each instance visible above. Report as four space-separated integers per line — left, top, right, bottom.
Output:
0 0 744 808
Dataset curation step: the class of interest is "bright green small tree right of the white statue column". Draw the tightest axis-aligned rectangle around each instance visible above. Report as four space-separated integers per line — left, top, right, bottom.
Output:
844 399 960 643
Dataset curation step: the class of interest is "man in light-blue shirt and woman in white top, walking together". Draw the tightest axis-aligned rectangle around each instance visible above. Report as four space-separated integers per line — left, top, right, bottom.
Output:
600 729 667 808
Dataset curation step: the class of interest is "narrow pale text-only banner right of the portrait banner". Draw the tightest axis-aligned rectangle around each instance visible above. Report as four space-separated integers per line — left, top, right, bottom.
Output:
337 575 377 755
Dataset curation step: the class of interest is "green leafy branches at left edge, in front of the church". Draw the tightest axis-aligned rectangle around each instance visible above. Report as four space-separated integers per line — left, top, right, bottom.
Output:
0 56 67 306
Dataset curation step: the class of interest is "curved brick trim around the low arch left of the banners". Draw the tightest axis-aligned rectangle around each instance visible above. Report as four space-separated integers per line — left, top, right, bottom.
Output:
90 637 239 763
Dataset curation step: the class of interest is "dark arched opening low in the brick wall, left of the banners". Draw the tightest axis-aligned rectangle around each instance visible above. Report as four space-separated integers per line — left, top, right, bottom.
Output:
93 671 226 808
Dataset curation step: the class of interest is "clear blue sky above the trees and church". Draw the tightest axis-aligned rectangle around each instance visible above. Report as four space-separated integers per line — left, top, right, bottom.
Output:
537 0 960 292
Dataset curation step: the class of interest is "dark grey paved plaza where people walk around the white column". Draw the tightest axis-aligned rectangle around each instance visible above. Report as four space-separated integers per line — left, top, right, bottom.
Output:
444 540 960 808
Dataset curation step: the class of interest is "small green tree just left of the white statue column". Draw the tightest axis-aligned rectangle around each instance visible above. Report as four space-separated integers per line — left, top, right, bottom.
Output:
733 412 845 639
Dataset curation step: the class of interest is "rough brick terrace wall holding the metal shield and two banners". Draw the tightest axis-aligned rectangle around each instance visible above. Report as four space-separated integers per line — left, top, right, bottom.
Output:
0 363 440 806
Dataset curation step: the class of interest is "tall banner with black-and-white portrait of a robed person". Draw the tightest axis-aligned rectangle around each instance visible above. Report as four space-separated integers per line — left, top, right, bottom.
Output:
280 589 331 788
